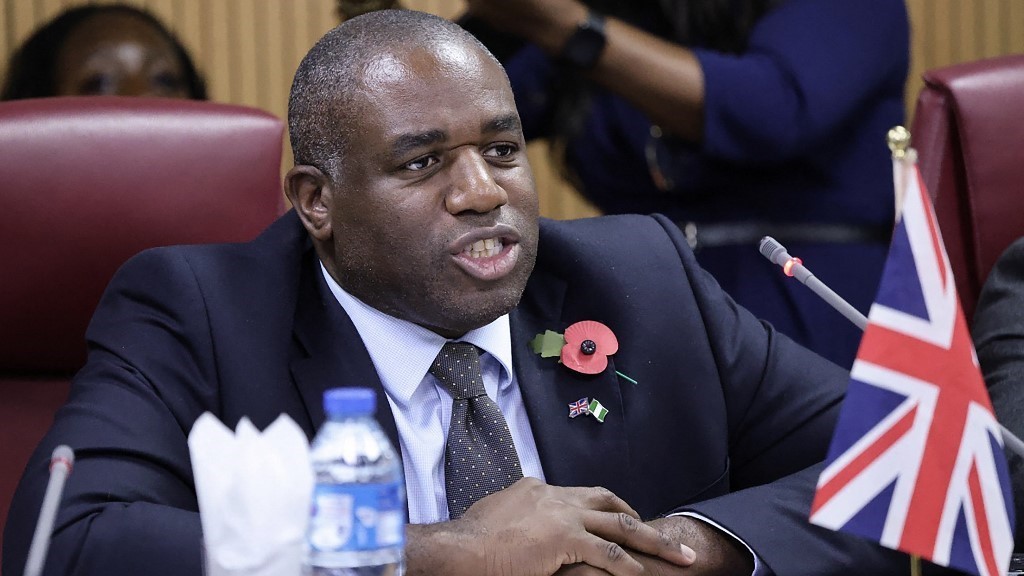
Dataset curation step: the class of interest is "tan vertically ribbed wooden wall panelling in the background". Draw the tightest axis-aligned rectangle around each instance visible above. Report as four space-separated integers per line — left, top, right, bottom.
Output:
0 0 1024 217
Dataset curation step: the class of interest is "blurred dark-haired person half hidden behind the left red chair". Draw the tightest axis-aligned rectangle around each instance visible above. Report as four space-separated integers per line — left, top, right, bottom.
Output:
0 4 207 100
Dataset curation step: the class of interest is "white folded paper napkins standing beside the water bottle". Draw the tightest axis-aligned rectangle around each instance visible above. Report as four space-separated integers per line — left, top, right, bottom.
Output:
188 412 313 576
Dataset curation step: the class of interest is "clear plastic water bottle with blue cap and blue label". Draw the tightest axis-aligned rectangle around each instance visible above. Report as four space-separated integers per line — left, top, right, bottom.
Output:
305 387 406 576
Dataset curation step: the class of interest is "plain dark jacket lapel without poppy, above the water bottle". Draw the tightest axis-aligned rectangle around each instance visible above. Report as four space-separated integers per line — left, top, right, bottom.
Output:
292 255 401 449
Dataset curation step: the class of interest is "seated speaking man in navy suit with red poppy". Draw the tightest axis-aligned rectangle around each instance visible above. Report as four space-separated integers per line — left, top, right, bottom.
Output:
4 11 905 576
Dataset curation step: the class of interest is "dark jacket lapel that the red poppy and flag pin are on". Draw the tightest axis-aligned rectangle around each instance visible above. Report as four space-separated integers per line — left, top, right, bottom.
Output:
511 273 631 500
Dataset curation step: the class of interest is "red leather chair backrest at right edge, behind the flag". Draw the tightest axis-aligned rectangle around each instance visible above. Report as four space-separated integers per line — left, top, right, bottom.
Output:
910 54 1024 322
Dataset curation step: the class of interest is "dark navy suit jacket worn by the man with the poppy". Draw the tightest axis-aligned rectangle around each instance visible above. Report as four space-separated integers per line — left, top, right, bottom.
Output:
3 213 907 576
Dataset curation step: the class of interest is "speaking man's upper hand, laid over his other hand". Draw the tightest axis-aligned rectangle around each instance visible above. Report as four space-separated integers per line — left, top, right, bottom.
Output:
409 478 693 576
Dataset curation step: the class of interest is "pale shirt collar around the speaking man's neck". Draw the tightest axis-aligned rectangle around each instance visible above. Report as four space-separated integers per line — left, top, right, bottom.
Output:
319 262 513 404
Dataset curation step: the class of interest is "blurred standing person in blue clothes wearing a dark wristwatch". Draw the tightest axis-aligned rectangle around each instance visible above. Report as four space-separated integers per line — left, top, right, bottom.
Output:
460 0 909 368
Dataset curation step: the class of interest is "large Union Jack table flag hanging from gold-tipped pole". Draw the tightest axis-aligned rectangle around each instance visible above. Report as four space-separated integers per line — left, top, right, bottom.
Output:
811 154 1014 576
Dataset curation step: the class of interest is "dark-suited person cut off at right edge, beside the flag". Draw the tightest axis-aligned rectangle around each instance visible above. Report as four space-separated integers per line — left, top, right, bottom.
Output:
972 238 1024 551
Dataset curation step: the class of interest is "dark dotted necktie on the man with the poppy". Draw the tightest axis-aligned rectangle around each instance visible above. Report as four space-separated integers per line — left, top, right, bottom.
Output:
430 342 522 520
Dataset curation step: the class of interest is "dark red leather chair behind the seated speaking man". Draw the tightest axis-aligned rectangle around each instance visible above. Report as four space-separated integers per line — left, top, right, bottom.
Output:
0 96 285 553
